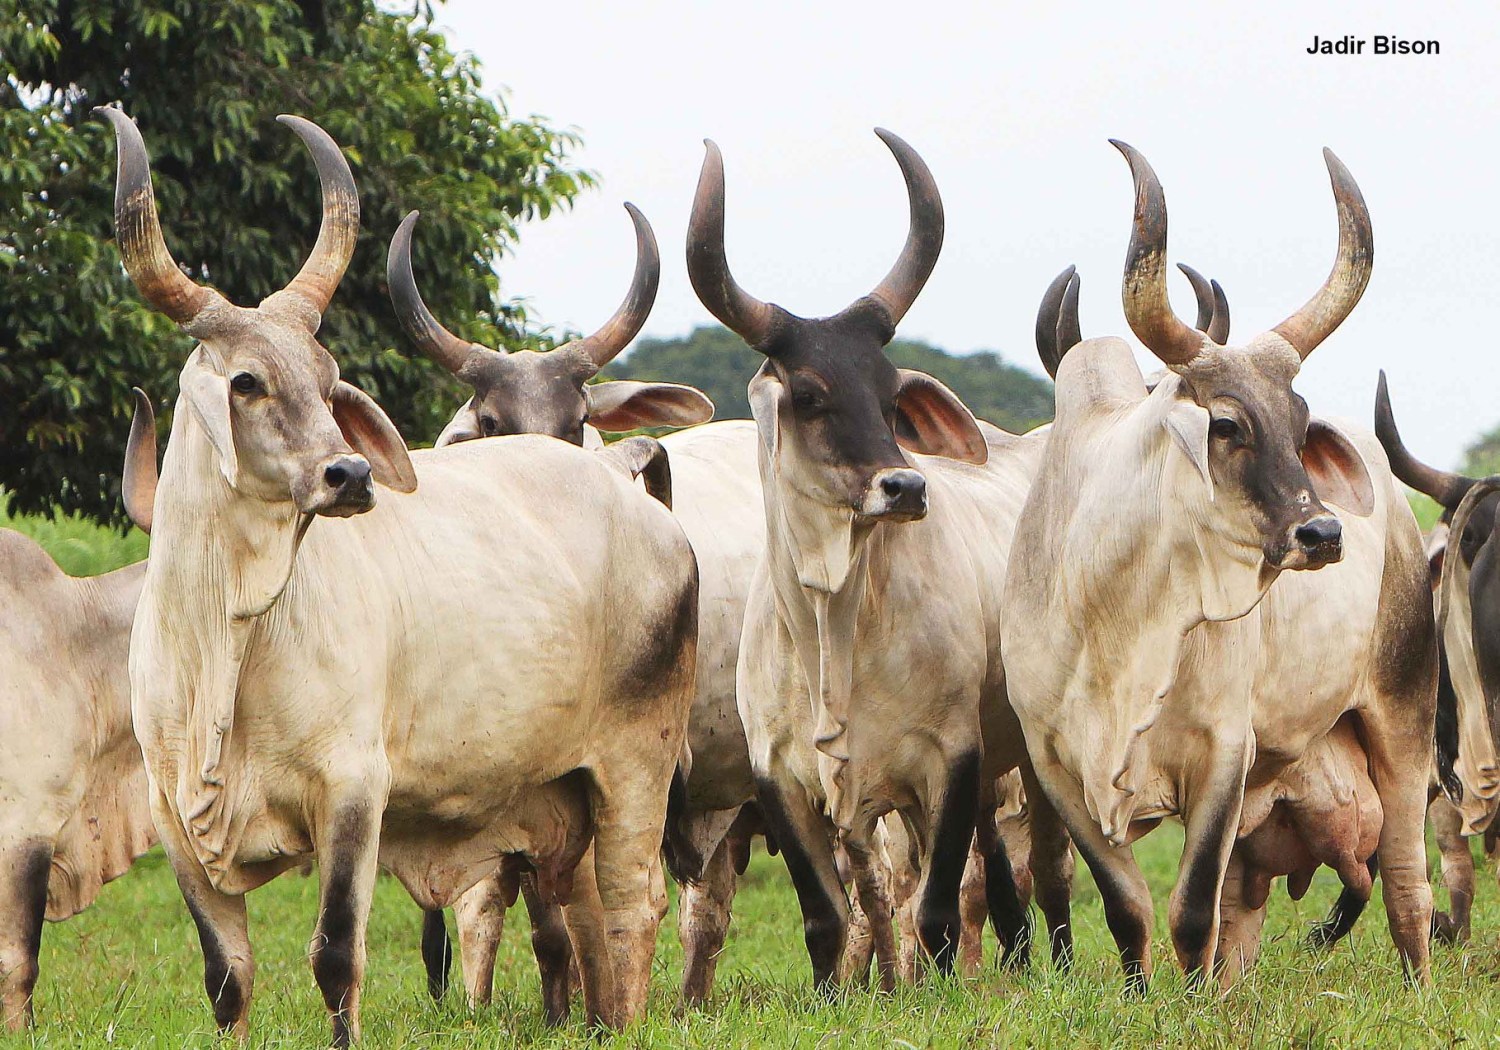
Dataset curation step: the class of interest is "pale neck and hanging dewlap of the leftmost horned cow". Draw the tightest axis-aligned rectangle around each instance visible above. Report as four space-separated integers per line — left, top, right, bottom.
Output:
147 398 311 875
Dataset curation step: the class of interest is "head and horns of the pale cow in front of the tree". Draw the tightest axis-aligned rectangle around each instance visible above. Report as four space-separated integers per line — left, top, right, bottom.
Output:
95 107 416 516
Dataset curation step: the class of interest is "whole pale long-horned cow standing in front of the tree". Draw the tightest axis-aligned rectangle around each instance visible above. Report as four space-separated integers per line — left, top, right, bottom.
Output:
99 108 698 1046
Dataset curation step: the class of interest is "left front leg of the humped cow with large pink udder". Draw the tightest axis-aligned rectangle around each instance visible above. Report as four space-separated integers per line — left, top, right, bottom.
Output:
1026 765 1155 996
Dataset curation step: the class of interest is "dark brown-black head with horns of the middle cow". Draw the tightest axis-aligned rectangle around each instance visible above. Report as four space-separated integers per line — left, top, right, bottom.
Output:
687 131 989 522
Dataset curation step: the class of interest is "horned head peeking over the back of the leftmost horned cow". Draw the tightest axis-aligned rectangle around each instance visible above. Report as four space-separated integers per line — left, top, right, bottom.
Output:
386 204 714 447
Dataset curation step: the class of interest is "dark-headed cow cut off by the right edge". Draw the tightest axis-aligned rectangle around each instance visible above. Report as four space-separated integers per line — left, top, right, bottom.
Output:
1314 372 1500 947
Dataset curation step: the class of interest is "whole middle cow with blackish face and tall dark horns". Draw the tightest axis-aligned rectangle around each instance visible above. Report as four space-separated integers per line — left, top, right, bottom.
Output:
687 131 1070 989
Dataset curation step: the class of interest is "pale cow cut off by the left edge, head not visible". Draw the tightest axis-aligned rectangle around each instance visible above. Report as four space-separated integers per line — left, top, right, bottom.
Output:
0 516 156 1031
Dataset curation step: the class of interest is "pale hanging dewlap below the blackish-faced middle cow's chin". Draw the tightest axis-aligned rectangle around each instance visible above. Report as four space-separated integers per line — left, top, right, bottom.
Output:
759 443 881 831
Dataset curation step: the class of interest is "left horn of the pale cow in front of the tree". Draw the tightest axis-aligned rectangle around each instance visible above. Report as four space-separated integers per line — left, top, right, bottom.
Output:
93 107 216 324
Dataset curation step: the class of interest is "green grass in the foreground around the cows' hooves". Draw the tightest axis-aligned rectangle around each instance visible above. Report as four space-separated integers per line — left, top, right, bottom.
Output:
0 827 1500 1049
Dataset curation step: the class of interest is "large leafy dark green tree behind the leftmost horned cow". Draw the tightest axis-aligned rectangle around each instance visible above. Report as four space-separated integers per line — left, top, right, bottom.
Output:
0 0 591 521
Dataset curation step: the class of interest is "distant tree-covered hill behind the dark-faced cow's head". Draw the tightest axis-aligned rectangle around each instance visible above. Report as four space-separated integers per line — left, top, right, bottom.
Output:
605 326 1052 434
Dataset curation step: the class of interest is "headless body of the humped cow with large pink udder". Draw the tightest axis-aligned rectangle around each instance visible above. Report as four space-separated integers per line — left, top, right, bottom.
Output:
1004 339 1436 984
